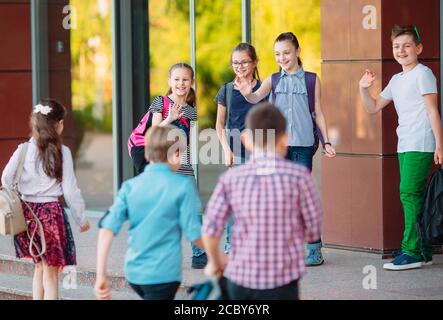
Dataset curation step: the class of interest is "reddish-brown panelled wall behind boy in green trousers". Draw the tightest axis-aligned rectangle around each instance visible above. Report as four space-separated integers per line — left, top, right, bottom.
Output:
321 0 440 252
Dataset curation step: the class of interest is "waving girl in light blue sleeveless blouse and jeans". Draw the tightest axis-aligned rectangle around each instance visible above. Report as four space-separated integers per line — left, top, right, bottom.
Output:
239 32 336 266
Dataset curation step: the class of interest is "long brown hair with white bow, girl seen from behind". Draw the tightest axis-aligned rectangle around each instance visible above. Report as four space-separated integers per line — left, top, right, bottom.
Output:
30 99 66 182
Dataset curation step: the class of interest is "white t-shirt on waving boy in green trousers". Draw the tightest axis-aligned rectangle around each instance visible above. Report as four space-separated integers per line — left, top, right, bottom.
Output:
380 64 438 152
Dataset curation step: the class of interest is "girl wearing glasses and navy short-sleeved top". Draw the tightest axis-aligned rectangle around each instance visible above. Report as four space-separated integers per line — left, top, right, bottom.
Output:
215 43 261 253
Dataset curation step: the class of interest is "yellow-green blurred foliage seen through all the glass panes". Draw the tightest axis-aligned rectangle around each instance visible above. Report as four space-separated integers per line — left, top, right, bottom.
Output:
71 0 320 133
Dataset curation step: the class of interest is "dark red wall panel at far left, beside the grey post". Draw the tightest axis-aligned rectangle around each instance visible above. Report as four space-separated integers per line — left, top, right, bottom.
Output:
0 0 32 171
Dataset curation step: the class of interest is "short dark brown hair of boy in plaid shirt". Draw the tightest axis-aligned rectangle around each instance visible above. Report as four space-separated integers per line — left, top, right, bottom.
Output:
246 102 286 147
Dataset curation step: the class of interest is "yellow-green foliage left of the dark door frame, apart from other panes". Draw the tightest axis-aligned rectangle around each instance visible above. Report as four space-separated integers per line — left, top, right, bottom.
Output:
70 0 112 133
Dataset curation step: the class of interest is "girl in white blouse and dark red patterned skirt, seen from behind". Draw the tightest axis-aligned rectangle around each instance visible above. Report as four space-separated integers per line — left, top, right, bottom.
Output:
2 99 89 300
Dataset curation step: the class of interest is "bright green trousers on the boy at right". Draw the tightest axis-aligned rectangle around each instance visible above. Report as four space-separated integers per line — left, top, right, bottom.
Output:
398 152 434 258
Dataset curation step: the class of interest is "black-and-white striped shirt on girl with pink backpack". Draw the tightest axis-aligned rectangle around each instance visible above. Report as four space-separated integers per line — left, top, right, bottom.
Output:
149 96 197 176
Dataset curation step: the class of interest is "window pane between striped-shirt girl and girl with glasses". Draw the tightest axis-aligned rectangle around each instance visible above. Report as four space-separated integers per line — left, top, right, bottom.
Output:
196 0 242 205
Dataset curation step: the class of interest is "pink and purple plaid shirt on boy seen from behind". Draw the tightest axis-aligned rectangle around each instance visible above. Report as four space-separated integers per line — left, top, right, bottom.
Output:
203 154 322 290
